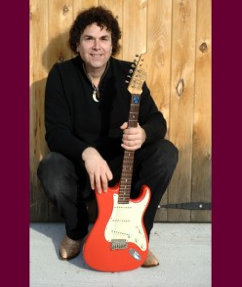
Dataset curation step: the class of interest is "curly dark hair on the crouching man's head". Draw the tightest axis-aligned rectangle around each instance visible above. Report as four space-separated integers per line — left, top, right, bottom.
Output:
68 6 121 56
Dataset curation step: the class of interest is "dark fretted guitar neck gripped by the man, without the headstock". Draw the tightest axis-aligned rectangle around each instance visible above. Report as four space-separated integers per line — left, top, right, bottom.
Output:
119 94 140 204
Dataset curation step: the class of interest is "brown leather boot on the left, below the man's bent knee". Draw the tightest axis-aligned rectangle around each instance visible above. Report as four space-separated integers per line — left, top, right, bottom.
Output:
59 235 82 260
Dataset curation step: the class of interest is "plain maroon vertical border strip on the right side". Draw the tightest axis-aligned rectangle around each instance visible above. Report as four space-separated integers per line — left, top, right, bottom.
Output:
212 0 242 287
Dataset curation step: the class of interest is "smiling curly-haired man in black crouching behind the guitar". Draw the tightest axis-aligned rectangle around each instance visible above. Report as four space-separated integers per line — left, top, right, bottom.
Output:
38 6 178 267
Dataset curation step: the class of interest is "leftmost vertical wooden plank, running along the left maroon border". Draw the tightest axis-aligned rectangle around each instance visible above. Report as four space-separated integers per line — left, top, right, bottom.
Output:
29 0 48 221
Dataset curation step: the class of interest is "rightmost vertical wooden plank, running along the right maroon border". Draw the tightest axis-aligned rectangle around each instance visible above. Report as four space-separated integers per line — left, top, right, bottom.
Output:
191 0 211 222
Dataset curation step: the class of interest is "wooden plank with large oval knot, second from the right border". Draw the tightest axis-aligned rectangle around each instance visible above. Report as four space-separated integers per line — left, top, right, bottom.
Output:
168 0 196 222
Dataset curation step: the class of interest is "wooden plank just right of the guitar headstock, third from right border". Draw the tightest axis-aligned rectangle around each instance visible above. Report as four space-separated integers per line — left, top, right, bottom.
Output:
147 0 172 221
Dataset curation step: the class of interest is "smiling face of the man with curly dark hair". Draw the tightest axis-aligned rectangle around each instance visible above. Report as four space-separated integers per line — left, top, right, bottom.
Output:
76 23 112 70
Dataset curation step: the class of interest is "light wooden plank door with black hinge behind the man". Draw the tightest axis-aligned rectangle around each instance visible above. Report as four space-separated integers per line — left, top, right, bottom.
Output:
30 0 211 222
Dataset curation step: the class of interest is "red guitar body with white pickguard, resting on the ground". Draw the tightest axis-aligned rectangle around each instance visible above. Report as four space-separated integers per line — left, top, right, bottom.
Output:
83 185 150 272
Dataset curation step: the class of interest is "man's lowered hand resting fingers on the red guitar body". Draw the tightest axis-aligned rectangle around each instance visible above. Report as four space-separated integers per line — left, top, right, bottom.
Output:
82 147 113 193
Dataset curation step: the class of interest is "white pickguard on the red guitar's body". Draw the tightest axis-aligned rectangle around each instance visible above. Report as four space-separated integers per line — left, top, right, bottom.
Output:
104 189 149 251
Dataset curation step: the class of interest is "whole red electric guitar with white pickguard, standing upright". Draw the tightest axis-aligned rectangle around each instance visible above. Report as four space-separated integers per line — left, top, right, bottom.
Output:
83 53 150 272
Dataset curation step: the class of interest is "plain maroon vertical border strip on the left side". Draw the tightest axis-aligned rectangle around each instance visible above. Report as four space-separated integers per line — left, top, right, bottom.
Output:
0 1 29 287
